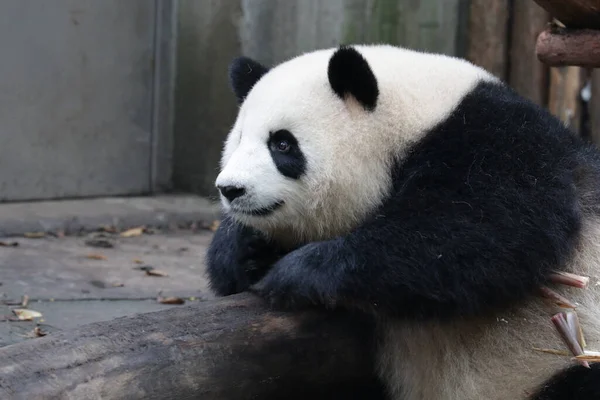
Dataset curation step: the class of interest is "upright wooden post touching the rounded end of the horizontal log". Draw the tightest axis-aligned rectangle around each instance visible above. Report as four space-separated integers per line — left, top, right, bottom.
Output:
508 1 550 106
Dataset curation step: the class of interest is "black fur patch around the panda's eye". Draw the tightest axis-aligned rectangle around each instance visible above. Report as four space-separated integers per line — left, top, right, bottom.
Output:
268 129 306 179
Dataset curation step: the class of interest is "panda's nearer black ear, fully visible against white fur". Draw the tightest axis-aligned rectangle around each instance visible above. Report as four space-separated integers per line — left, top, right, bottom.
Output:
327 46 379 111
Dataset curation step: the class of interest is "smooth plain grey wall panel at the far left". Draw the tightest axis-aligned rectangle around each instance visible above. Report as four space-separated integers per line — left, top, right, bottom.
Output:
0 0 175 201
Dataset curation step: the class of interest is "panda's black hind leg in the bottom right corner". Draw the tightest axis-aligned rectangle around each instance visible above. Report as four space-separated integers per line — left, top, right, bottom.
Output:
530 364 600 400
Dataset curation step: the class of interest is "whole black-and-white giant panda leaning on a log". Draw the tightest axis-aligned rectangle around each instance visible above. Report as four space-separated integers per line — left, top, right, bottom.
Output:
206 45 600 400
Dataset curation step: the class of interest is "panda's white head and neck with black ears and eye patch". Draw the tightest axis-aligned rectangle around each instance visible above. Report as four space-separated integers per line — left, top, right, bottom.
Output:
216 45 494 243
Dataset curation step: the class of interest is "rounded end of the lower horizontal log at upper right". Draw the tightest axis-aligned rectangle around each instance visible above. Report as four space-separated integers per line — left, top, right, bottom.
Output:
536 28 600 68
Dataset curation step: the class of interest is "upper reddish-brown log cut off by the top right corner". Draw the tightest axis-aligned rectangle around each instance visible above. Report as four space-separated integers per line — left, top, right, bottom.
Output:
534 0 600 29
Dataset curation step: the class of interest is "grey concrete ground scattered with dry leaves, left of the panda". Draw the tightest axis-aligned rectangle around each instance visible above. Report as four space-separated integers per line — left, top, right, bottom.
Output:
0 197 217 346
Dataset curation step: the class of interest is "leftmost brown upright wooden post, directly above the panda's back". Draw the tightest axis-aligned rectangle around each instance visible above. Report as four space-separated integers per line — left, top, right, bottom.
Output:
466 0 510 79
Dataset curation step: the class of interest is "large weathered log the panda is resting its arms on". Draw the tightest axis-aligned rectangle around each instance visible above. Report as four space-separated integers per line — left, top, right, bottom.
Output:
0 294 381 400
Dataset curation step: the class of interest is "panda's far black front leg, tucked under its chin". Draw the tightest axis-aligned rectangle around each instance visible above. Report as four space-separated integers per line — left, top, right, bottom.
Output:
206 217 285 296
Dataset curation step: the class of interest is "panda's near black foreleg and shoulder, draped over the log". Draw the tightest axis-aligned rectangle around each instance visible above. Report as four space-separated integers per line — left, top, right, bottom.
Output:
246 79 584 318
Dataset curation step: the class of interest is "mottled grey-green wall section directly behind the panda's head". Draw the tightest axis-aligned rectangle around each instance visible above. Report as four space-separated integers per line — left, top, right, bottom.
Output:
173 0 468 196
